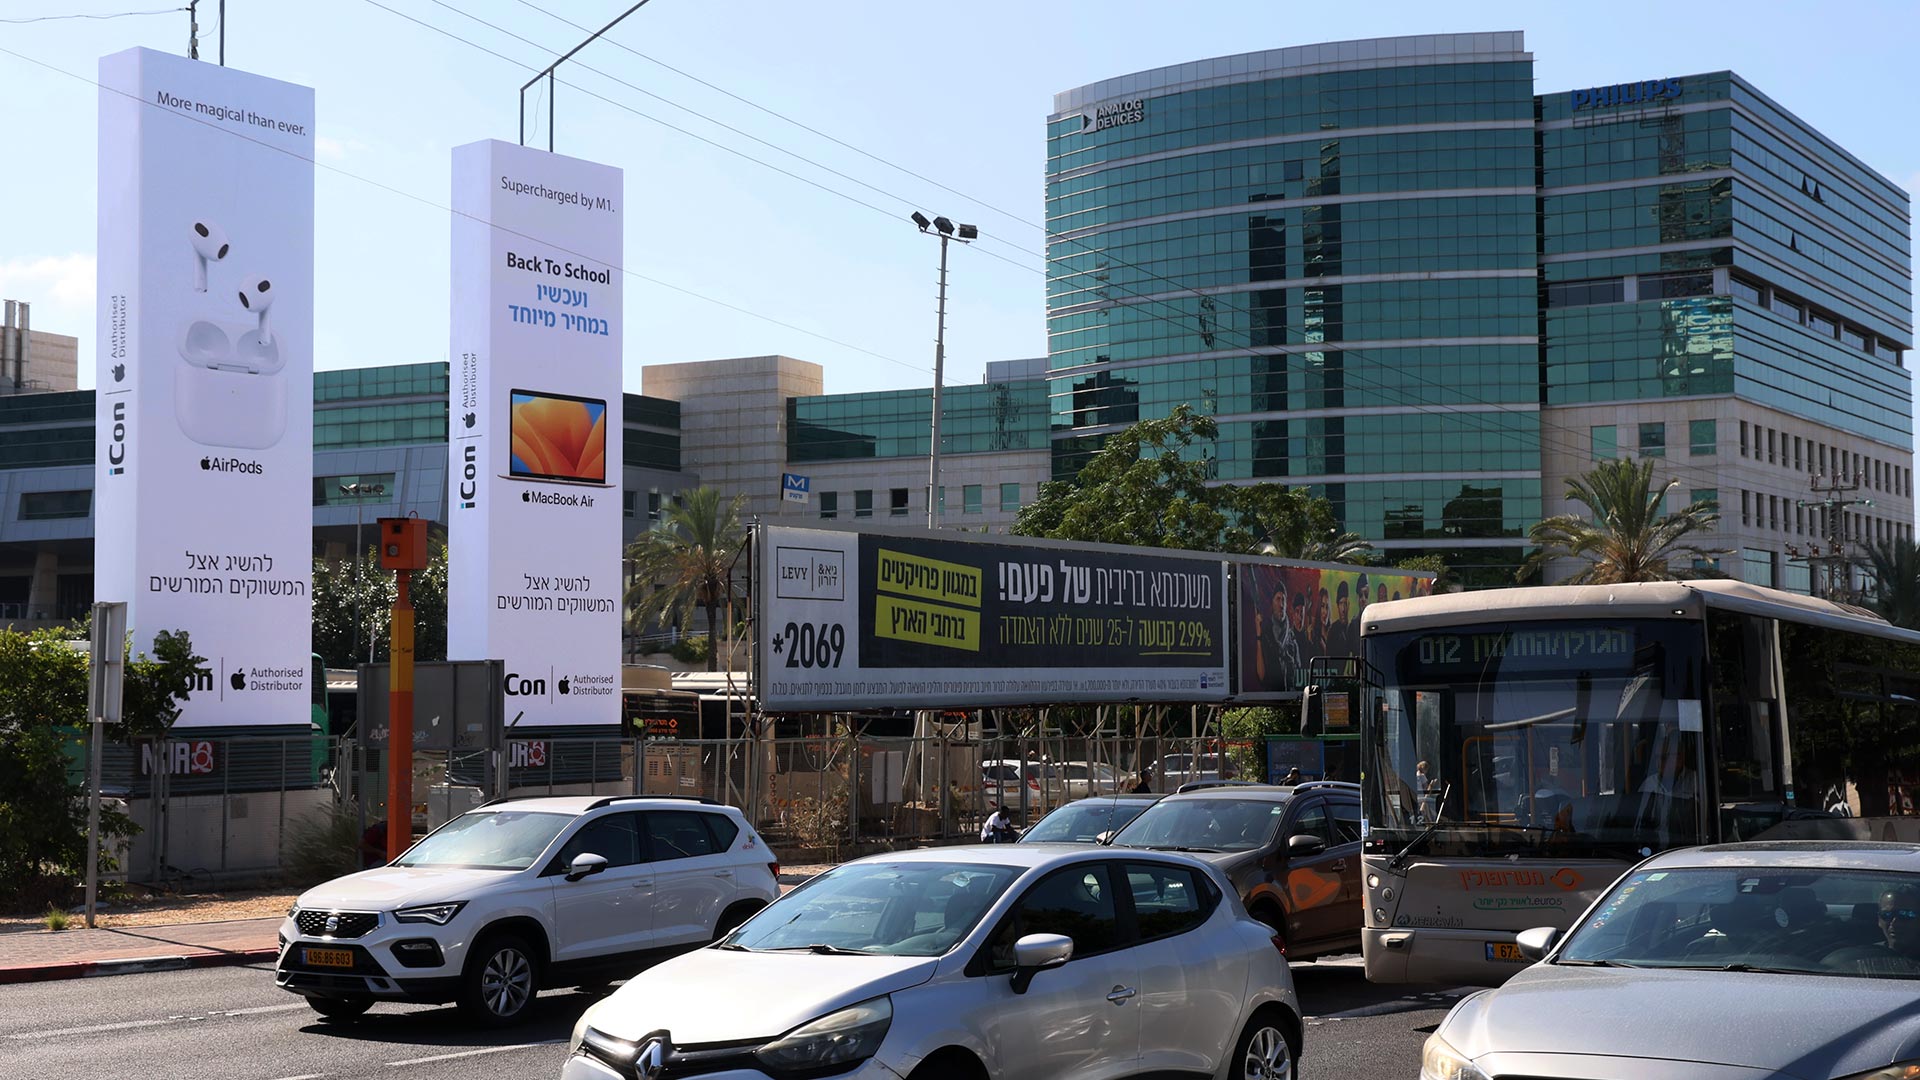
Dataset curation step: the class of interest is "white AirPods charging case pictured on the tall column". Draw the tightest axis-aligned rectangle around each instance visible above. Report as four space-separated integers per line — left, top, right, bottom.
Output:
173 319 286 450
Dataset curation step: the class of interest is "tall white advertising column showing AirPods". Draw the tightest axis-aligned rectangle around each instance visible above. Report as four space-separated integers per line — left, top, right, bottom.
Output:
94 48 313 726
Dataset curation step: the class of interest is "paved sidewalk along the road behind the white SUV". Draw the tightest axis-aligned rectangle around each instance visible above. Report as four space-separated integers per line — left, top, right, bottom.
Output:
0 865 828 984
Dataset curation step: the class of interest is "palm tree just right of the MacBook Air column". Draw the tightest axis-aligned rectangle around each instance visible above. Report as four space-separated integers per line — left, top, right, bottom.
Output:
626 488 747 671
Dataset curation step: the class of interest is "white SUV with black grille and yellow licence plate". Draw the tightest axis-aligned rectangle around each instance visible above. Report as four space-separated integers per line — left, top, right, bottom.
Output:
275 796 780 1022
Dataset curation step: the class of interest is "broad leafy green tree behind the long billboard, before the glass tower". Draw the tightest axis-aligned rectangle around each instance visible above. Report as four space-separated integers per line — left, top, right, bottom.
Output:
1014 405 1371 561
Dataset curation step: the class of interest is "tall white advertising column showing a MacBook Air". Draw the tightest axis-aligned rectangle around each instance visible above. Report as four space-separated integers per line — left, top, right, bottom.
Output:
447 140 624 728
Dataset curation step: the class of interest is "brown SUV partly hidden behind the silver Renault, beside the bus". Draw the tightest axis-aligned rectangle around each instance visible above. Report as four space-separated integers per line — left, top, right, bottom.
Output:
1112 780 1363 961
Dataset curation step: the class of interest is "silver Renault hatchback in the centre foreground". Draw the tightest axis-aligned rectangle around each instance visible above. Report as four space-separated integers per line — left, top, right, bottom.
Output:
561 844 1300 1080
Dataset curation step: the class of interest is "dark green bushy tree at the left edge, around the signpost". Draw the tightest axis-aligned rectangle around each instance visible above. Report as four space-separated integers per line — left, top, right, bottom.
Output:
0 618 205 903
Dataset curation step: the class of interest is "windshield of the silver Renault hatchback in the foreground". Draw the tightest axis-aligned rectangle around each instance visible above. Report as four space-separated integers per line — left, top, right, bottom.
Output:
720 863 1020 957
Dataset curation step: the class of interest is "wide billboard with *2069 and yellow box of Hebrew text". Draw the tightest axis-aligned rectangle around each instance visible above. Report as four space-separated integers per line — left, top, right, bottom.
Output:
760 528 1229 711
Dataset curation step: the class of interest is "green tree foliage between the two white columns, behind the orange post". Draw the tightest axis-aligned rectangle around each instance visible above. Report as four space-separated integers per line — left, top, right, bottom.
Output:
313 538 447 669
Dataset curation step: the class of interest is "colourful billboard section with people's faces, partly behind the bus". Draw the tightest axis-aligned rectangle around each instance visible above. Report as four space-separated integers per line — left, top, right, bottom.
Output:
1235 563 1434 701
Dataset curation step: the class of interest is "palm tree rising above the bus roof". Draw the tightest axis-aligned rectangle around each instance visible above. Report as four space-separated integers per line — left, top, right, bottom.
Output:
1519 457 1722 584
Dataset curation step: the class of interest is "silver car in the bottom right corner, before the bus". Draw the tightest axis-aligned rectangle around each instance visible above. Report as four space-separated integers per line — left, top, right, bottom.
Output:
1421 842 1920 1080
